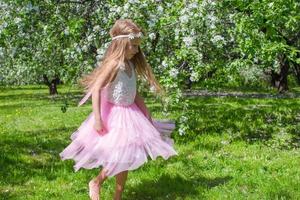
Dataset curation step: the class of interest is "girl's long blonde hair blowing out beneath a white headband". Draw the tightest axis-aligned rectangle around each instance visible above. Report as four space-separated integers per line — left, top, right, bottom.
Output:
79 19 165 98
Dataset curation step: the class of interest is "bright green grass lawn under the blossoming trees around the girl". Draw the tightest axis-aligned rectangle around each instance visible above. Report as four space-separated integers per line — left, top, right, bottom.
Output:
0 86 300 200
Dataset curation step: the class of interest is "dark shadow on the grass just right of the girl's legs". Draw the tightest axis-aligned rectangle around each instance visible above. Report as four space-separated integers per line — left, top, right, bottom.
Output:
124 174 232 200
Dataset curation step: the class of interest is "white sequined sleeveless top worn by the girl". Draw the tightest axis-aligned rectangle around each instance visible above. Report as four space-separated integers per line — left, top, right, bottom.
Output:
103 61 136 106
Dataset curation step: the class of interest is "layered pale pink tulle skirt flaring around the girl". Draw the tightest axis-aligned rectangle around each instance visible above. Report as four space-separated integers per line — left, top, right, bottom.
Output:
59 95 177 176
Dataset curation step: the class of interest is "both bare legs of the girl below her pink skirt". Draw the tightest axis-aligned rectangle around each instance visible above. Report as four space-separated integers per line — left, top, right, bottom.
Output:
89 169 128 200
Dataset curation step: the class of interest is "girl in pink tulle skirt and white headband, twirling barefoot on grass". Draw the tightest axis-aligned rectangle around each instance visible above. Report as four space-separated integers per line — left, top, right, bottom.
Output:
60 19 177 200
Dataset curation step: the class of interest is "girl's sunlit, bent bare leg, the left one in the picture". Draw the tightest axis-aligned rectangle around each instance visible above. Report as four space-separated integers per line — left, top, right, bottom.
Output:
89 169 107 200
